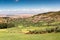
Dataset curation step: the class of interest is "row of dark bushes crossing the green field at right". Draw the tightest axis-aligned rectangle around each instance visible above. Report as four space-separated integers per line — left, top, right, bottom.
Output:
26 27 60 34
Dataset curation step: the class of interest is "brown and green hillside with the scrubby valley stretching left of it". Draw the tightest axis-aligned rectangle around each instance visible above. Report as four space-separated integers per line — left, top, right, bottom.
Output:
0 11 60 27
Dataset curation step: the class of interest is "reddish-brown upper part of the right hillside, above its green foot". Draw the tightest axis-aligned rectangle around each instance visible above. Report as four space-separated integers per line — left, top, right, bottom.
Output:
32 11 60 22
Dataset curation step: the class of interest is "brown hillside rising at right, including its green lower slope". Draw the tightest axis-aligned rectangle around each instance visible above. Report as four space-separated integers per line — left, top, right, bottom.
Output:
22 11 60 26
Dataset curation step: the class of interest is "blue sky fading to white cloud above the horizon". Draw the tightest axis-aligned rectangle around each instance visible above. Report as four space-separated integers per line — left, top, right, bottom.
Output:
0 0 60 14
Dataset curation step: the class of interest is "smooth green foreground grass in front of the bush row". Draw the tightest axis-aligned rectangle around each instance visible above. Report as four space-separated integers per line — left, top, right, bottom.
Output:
0 29 60 40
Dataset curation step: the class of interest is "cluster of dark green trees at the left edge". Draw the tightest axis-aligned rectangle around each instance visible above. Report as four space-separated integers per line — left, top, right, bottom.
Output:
0 17 15 29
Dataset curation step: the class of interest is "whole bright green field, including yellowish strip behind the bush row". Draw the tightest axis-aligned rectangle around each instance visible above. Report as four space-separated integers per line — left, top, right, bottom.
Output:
0 27 60 40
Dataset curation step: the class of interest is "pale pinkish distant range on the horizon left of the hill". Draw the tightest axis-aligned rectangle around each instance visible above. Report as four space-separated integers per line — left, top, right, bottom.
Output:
0 14 33 18
